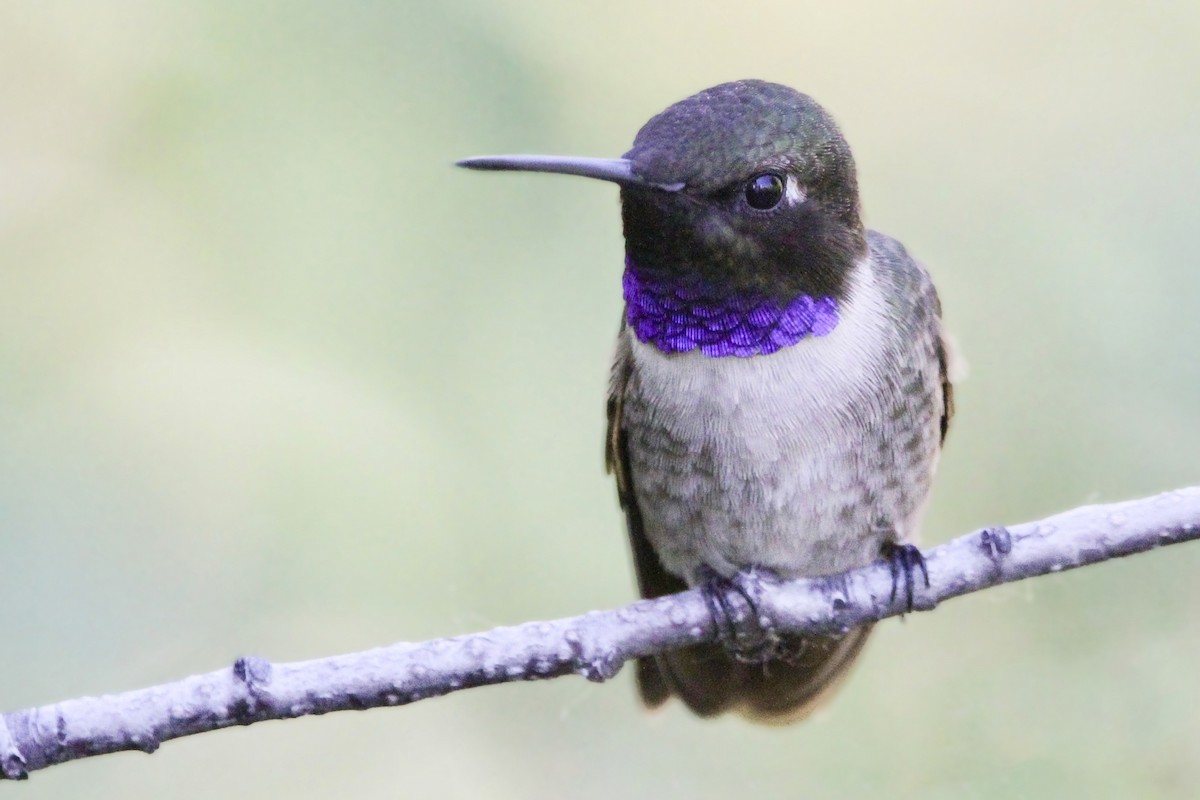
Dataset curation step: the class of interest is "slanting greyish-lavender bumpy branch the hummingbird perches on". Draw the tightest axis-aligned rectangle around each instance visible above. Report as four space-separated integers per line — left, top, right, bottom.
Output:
0 487 1200 780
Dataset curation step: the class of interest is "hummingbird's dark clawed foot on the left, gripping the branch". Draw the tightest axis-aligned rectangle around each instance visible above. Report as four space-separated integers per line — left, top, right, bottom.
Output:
700 567 780 663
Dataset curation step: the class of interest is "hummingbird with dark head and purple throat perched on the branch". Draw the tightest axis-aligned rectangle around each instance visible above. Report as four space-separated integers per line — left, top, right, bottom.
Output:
458 80 953 723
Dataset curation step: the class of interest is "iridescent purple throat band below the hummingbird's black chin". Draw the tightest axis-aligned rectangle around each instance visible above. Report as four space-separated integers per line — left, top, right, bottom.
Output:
623 258 839 359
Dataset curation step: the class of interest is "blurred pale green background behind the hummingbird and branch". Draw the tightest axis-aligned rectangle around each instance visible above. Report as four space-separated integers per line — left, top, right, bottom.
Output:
0 0 1200 799
